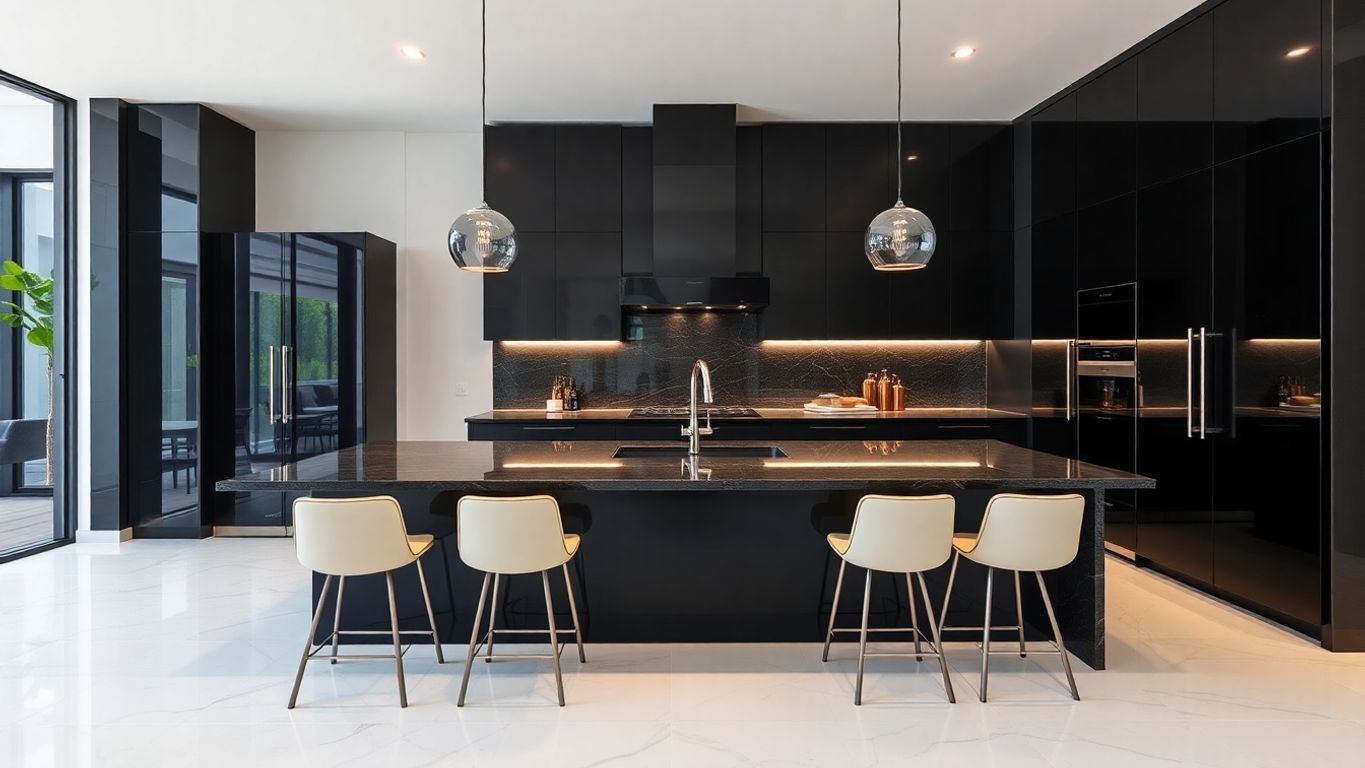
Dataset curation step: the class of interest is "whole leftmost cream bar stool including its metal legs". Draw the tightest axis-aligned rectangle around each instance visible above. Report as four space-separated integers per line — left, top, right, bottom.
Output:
289 497 445 709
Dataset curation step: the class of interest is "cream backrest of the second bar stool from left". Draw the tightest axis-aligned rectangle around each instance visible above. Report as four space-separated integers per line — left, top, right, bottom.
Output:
456 495 569 574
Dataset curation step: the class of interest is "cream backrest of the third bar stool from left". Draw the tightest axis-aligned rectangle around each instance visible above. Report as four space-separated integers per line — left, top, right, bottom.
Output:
844 494 956 573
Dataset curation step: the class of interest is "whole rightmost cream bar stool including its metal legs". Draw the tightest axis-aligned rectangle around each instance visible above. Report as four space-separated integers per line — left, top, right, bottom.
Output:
939 494 1085 701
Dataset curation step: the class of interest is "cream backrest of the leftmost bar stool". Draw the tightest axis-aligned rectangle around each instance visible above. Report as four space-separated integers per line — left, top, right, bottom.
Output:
293 497 416 576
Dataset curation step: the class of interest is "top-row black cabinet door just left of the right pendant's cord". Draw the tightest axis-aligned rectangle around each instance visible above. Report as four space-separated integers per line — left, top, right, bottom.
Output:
824 124 893 231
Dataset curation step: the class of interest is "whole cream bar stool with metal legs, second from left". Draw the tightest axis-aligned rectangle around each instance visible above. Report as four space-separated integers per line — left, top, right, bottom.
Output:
456 495 587 707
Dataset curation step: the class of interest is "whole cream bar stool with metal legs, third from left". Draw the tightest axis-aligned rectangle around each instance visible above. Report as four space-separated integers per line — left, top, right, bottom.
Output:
820 494 956 705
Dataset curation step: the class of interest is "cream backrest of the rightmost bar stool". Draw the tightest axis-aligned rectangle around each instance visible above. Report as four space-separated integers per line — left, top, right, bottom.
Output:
972 494 1085 570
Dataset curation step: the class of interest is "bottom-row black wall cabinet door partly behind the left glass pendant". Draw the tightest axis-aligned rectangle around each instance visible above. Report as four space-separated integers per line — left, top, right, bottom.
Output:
483 232 556 341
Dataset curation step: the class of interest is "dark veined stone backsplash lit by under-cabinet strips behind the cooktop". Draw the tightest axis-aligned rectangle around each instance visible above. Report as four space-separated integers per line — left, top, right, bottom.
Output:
493 312 987 408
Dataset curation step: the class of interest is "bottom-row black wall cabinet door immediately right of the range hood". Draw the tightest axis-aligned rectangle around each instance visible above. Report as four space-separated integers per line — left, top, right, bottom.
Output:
762 232 824 338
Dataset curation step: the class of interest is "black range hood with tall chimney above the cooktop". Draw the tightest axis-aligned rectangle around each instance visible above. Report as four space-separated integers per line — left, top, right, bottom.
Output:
621 104 768 310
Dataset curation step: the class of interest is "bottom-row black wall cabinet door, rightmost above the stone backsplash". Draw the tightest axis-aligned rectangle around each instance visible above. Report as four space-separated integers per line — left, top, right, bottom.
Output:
950 232 1014 338
